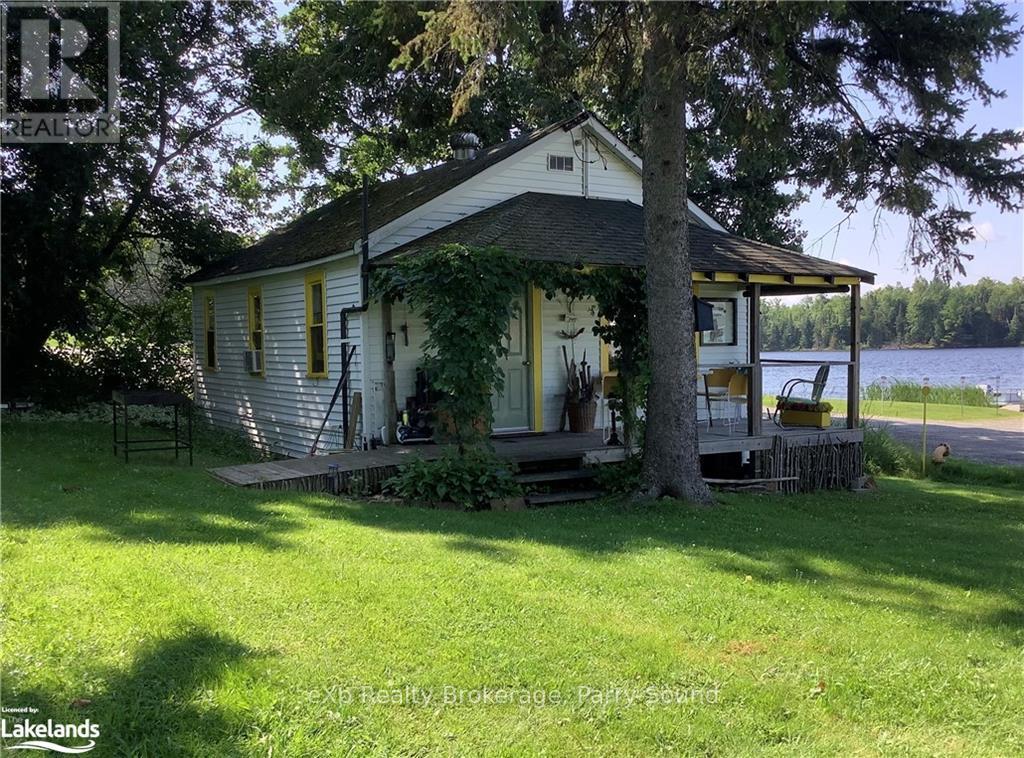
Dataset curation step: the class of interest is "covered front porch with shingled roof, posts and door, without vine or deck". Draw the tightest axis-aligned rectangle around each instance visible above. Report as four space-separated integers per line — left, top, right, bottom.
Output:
369 193 873 452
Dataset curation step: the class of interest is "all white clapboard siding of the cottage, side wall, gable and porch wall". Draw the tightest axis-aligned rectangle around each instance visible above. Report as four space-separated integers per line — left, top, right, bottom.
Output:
194 118 746 456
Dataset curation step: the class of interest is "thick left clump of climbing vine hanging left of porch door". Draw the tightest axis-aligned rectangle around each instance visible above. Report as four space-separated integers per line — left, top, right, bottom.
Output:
374 245 527 449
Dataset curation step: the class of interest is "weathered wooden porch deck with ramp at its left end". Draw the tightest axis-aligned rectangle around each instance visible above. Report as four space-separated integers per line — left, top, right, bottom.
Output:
210 427 863 492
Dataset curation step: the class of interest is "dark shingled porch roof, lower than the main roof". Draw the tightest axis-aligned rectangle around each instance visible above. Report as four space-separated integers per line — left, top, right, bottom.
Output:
373 193 874 283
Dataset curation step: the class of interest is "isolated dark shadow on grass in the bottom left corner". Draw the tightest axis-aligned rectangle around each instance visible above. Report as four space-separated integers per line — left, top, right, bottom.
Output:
3 629 252 756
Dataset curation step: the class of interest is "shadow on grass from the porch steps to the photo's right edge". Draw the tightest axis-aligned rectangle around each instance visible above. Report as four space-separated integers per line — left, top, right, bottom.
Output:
305 480 1024 642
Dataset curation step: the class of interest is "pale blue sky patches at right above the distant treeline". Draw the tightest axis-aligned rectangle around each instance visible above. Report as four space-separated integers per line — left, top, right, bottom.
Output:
796 48 1024 285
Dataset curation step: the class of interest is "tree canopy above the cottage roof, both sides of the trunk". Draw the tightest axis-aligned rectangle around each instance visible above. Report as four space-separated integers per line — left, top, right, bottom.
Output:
258 2 1024 266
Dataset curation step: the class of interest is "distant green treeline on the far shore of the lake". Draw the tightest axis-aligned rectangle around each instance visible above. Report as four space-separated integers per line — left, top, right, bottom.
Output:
762 277 1024 350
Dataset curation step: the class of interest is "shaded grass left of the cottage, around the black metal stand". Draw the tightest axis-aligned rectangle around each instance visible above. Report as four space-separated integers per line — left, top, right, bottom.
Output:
2 422 300 550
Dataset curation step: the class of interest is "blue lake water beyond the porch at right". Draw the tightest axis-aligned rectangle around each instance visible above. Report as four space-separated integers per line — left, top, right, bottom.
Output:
761 347 1024 397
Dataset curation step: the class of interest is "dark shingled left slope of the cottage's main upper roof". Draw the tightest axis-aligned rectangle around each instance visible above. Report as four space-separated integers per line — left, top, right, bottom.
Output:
185 113 589 283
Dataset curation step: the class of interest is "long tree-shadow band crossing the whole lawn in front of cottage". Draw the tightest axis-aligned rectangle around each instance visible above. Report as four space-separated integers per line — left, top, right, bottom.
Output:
3 425 1024 637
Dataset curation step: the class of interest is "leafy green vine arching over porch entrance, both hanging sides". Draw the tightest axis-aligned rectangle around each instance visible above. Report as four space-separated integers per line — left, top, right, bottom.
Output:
374 245 649 450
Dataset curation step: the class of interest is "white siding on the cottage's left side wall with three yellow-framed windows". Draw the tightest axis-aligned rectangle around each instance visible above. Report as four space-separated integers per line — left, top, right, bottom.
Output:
193 260 361 456
